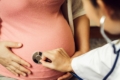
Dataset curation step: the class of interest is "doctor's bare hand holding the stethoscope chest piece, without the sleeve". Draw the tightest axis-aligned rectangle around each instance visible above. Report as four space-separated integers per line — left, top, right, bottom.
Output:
40 48 72 72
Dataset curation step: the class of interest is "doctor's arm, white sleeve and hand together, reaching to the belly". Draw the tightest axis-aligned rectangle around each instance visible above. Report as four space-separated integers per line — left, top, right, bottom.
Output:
41 44 115 80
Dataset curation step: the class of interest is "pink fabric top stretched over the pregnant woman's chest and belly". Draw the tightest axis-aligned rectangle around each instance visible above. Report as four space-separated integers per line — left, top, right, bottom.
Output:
0 0 75 80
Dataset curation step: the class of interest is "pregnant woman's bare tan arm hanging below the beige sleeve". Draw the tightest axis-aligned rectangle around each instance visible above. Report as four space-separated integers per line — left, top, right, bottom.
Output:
74 15 90 54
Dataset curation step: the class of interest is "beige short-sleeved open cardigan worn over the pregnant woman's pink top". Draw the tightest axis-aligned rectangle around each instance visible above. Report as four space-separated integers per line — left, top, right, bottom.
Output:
62 0 85 34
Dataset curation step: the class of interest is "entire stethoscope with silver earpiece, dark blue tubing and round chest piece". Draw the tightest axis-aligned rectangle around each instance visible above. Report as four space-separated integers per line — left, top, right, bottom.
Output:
32 16 120 80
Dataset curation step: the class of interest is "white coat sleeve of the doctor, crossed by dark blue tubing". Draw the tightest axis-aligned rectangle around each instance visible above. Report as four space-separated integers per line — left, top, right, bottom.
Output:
71 40 120 80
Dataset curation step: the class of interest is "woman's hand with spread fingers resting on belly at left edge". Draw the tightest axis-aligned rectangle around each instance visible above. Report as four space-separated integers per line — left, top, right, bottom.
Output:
0 41 31 76
